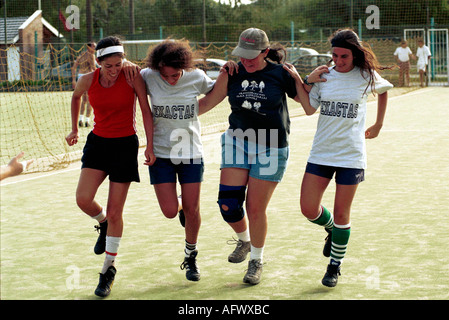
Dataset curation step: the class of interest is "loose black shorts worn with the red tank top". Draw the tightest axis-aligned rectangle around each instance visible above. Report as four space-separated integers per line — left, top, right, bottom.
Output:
81 132 140 183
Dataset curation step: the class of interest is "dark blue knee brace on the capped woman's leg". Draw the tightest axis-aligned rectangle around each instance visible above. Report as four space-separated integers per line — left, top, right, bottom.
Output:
218 184 246 222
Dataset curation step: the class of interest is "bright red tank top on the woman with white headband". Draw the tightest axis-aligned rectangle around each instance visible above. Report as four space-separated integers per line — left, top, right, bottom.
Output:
87 68 136 138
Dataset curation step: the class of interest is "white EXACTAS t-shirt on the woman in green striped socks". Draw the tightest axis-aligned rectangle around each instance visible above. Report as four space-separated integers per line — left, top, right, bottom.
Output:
308 67 393 169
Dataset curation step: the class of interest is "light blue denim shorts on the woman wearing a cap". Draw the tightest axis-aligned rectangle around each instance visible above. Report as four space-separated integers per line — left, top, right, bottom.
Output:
220 132 289 182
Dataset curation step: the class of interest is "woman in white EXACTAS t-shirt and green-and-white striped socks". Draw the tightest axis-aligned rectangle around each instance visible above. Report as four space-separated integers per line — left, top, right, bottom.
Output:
286 29 393 287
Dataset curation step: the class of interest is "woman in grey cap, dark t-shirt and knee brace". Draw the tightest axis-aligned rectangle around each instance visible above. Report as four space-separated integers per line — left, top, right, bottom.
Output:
200 28 302 284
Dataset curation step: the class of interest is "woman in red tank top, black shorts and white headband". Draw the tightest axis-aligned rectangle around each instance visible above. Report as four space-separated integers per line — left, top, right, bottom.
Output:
66 37 156 297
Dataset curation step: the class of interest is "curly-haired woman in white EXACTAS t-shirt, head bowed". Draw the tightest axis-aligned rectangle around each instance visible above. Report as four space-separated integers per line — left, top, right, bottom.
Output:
141 40 214 281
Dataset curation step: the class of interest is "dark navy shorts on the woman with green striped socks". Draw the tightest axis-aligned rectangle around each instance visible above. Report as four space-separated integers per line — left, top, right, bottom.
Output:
306 162 365 185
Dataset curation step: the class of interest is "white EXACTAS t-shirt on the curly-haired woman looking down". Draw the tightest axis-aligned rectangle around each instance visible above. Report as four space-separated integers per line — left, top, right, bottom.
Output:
140 68 215 160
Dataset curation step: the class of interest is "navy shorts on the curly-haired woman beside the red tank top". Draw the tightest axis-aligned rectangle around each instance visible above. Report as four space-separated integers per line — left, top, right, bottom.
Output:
148 158 204 184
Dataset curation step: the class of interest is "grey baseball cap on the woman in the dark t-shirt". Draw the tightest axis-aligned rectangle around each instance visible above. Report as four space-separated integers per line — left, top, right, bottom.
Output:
232 28 270 59
